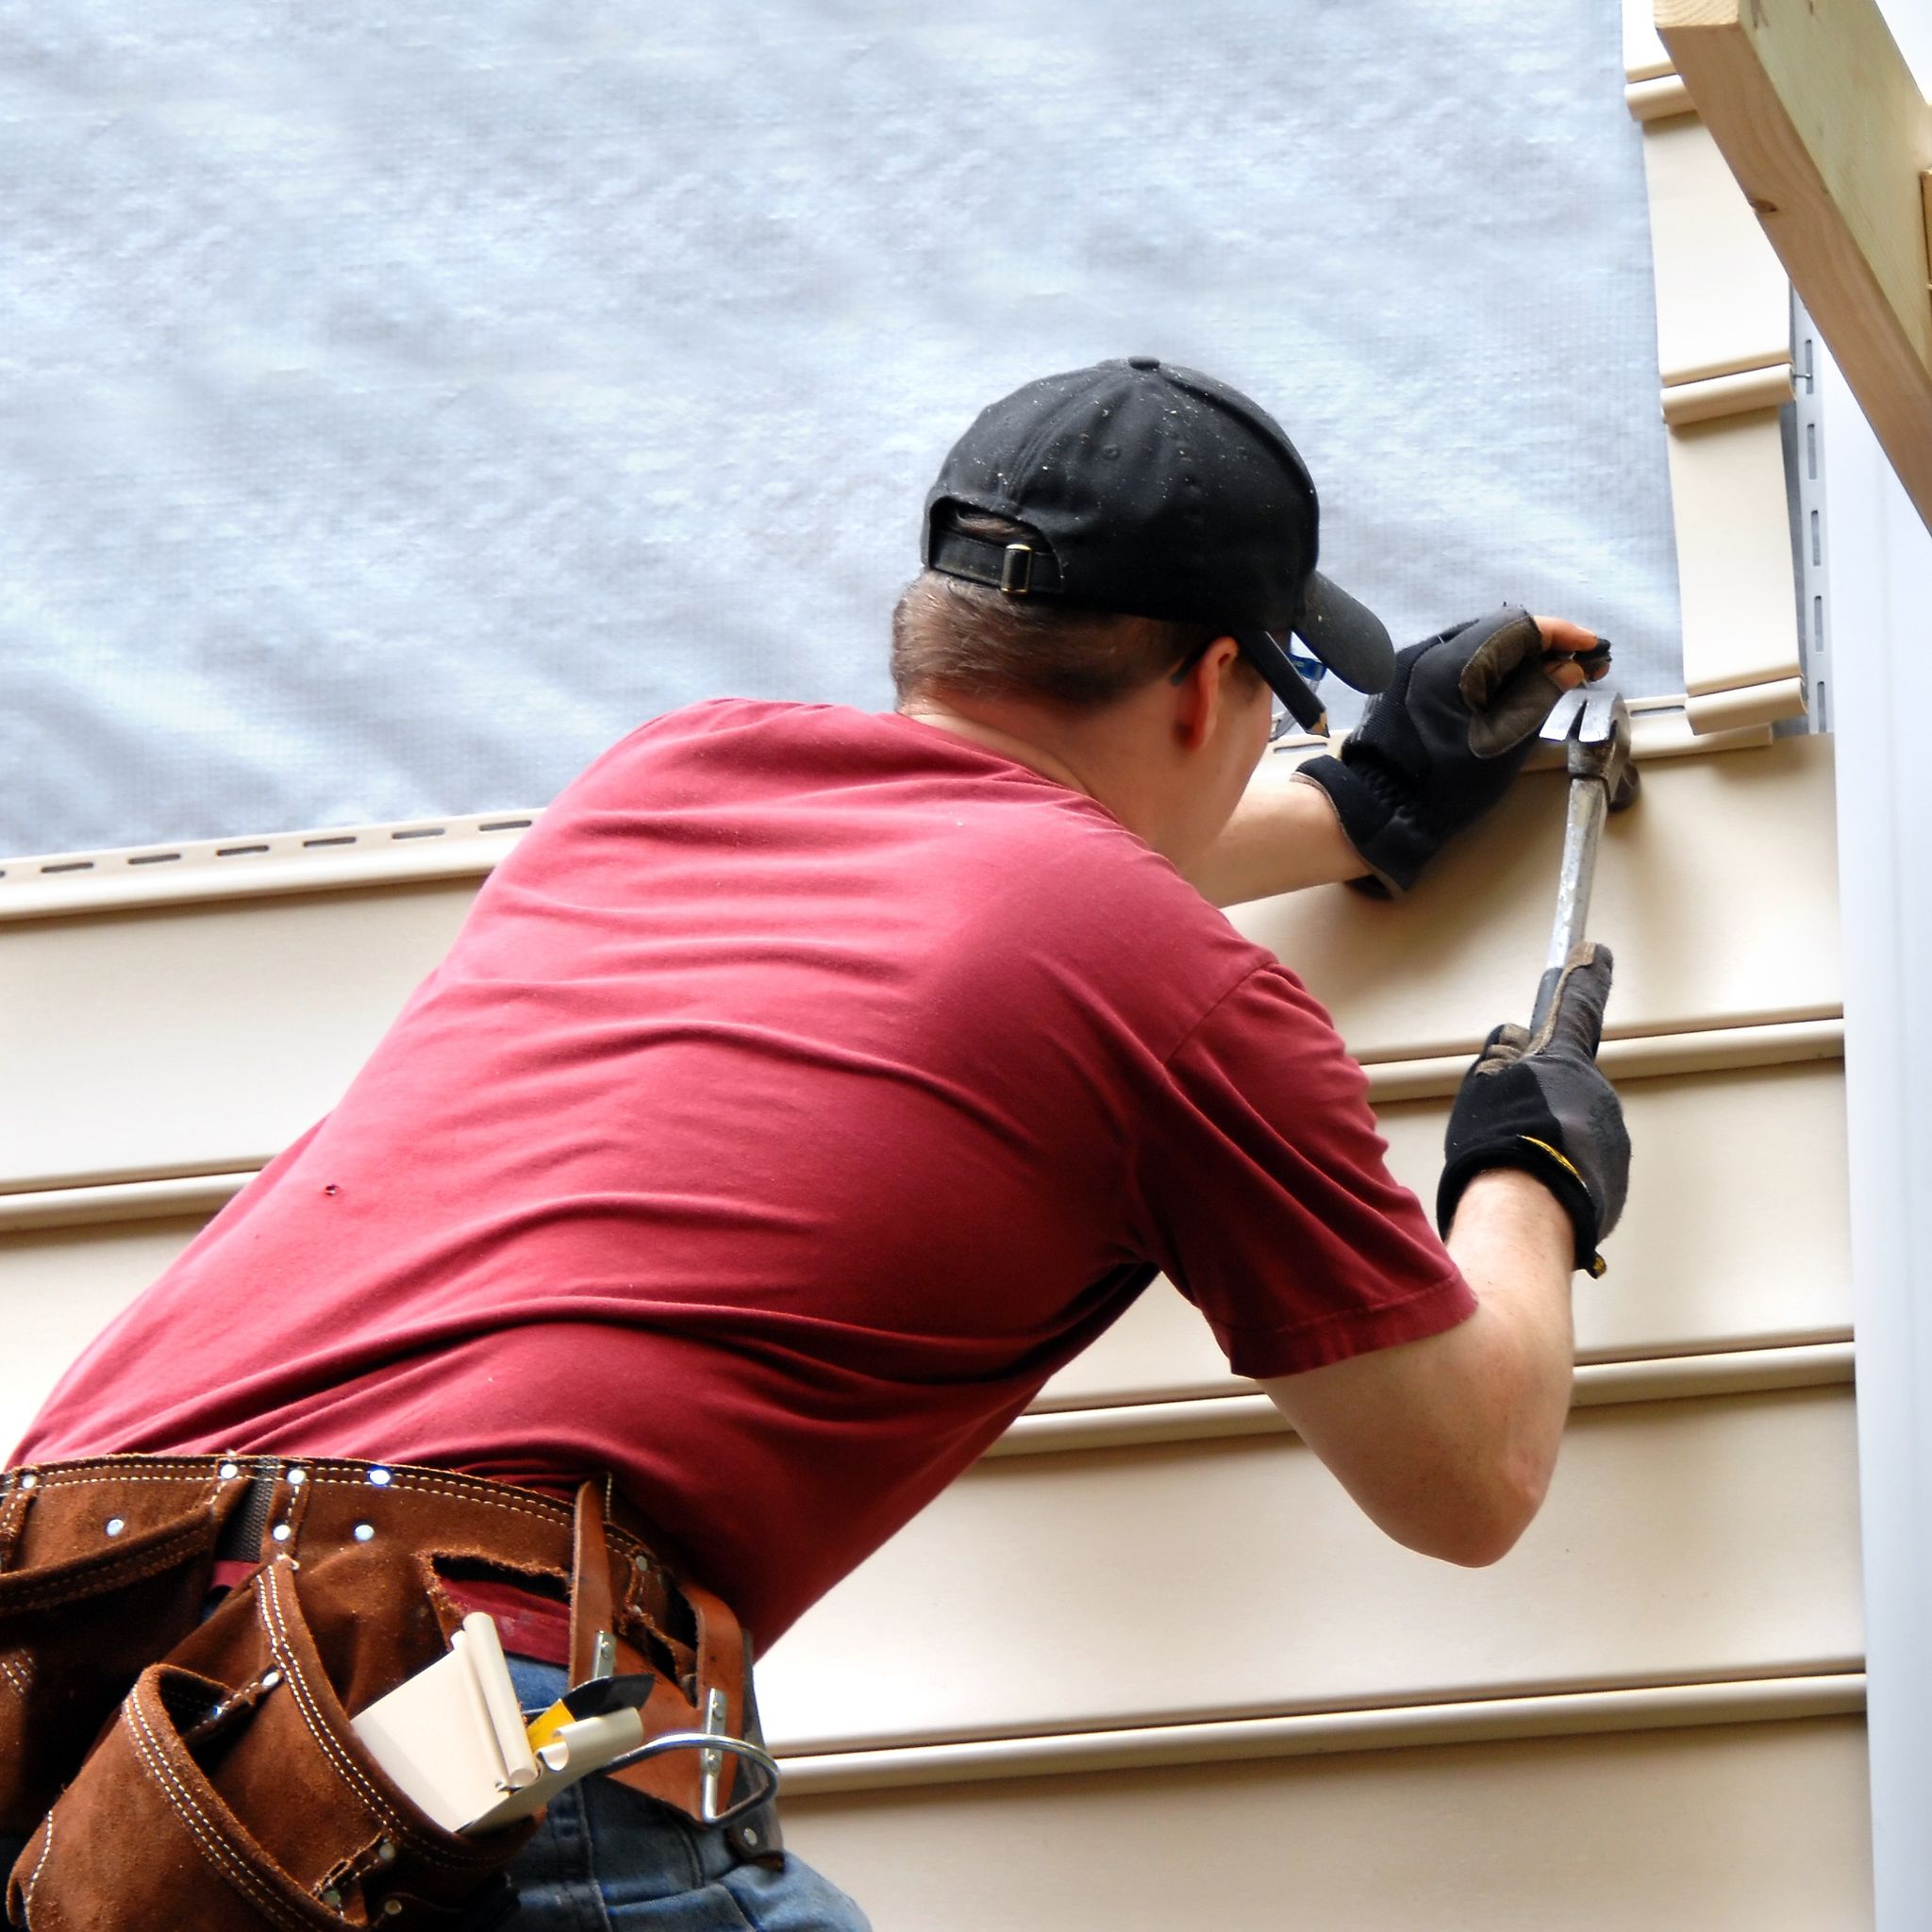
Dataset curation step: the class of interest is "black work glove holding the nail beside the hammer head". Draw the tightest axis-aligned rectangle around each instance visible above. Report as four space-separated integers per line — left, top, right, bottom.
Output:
1296 605 1584 896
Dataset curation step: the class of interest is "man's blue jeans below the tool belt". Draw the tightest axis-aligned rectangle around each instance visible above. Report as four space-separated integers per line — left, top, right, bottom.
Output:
505 1656 870 1932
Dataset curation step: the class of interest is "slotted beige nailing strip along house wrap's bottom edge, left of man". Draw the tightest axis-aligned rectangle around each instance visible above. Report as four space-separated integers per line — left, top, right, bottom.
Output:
0 811 537 920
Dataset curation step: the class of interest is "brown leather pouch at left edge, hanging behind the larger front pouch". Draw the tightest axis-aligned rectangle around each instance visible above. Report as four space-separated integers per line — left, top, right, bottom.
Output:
0 1462 243 1836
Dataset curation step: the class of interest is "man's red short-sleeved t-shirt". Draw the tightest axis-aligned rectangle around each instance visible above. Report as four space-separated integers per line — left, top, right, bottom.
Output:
17 701 1474 1644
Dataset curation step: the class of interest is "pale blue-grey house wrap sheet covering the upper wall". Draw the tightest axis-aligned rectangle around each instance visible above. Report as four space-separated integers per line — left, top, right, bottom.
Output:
0 0 1681 852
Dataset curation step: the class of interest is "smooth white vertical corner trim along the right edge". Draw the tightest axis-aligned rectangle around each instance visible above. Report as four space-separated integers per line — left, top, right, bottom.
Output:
1818 328 1932 1932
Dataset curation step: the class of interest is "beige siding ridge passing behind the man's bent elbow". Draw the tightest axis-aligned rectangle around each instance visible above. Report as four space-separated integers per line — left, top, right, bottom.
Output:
985 1337 1853 1460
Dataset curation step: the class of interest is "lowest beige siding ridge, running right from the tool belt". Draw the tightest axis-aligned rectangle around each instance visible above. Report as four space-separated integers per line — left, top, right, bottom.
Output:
778 1667 1864 1797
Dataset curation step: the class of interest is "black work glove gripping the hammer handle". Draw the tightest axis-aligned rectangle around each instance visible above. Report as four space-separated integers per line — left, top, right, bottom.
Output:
1436 941 1631 1275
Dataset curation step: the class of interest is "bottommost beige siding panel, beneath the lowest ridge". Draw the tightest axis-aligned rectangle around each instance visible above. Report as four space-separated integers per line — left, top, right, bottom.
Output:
787 1723 1873 1932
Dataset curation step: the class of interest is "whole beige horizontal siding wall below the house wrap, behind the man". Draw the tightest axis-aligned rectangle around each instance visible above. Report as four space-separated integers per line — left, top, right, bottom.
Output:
0 719 1870 1932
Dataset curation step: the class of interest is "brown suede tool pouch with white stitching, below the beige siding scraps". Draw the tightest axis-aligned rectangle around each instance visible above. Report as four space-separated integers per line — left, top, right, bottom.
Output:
8 1547 535 1932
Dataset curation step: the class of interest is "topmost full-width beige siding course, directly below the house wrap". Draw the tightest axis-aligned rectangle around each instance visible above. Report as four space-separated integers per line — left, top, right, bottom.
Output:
0 738 1840 1192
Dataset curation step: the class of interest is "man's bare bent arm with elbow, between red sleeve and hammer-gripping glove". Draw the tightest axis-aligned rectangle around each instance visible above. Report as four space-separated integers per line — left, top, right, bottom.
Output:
1261 1169 1574 1565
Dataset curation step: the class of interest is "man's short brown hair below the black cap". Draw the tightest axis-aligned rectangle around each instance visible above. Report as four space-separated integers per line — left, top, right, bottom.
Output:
892 508 1248 711
